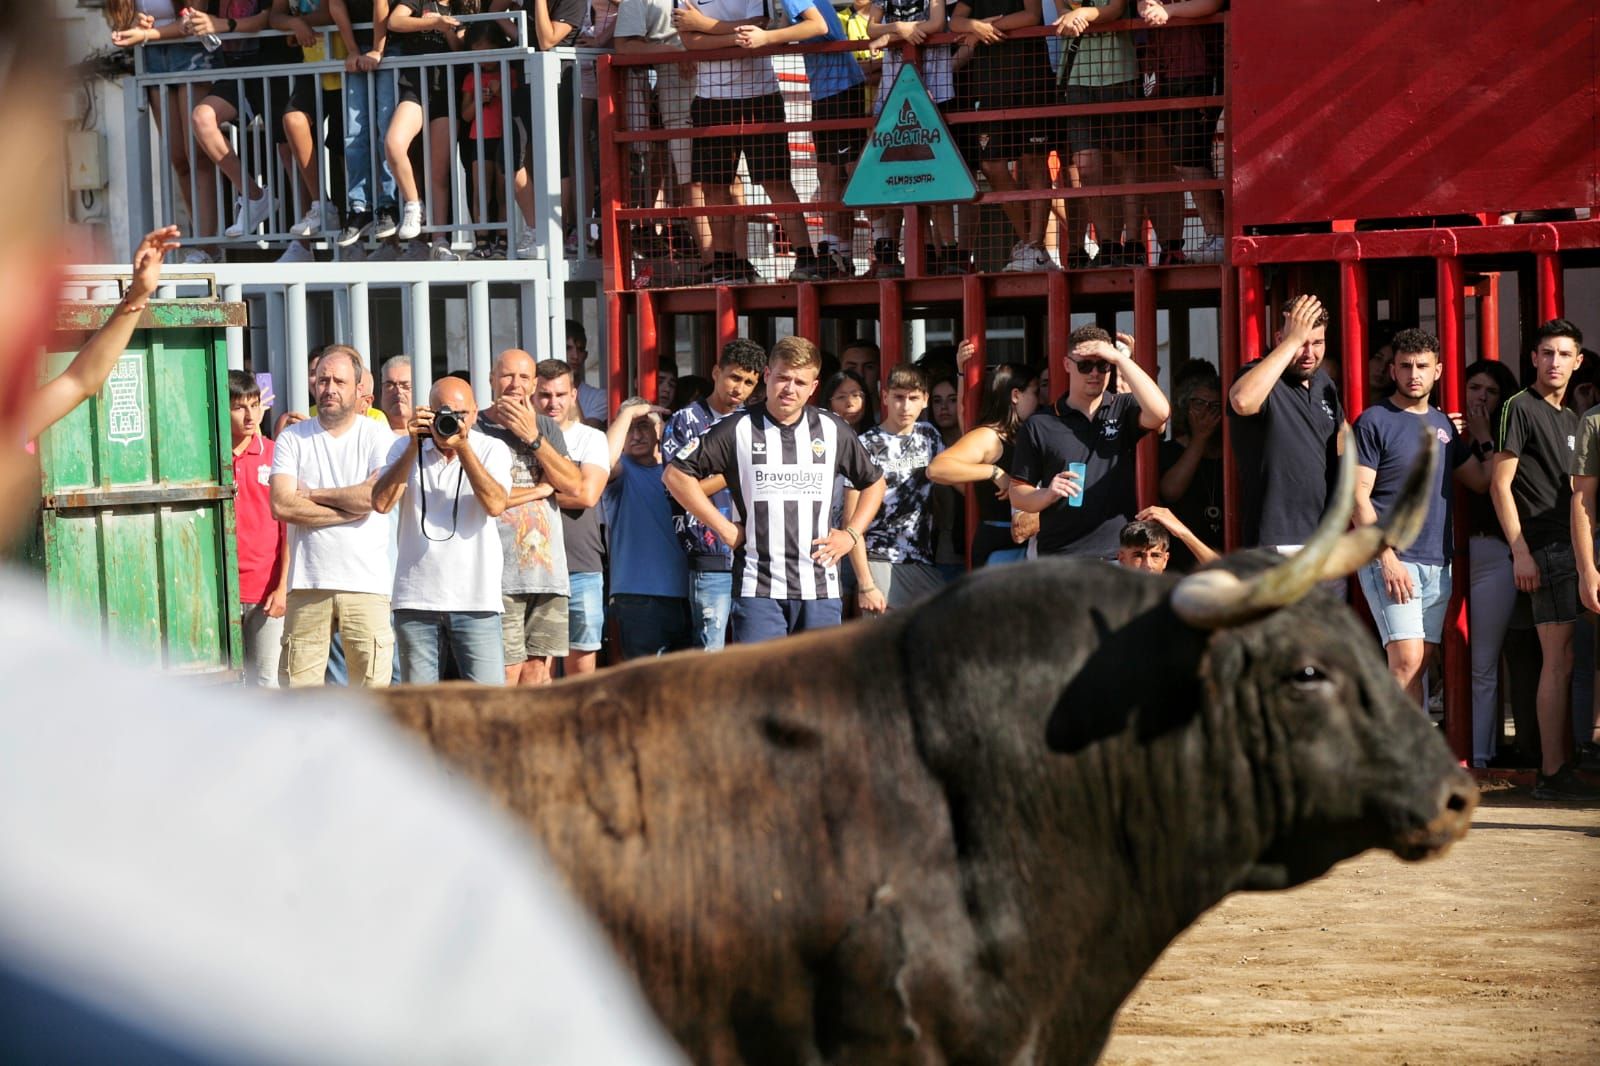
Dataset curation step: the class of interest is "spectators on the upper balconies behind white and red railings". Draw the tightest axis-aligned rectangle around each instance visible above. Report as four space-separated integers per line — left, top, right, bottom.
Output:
106 0 1226 270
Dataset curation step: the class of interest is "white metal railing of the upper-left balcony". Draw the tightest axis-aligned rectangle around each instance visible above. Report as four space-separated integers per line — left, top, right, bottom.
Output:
125 11 600 279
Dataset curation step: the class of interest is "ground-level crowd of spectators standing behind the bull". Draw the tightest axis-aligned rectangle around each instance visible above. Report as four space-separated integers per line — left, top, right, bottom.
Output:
234 296 1600 795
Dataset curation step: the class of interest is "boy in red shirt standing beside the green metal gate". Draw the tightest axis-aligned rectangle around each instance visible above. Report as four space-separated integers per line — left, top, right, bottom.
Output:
227 370 290 688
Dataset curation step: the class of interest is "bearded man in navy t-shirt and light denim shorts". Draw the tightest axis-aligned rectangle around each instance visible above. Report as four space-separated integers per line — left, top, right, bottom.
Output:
1354 330 1494 706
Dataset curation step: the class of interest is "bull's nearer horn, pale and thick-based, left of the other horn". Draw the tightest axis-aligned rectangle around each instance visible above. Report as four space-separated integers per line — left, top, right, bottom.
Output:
1173 429 1355 629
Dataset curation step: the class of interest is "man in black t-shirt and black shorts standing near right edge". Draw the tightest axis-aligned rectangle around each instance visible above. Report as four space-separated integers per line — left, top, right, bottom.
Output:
1490 319 1594 799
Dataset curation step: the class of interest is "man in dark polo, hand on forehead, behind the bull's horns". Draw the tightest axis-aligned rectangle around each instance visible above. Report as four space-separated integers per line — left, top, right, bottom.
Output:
1227 296 1344 551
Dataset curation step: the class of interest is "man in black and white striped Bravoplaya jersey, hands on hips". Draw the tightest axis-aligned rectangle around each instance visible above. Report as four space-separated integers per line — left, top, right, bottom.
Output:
664 336 883 643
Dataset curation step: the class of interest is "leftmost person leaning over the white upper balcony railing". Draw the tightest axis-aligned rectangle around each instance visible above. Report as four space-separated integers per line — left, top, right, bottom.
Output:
104 0 214 262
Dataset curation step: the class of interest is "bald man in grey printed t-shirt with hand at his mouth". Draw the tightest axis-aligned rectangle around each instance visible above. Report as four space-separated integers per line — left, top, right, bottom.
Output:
478 347 582 685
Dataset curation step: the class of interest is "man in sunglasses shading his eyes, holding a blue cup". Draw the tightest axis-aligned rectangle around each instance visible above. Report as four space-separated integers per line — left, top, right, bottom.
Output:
1011 327 1168 559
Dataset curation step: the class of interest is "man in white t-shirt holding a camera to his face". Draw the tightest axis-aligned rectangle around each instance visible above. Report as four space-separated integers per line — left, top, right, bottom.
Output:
373 378 512 685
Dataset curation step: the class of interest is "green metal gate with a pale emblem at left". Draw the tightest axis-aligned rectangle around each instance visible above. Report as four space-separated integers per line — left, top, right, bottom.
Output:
35 286 245 677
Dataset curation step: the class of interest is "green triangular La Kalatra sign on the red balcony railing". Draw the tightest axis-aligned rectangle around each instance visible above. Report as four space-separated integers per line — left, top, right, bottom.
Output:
845 62 978 206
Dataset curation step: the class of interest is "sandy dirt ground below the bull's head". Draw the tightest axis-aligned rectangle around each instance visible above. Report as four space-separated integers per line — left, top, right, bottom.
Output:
1102 789 1600 1066
